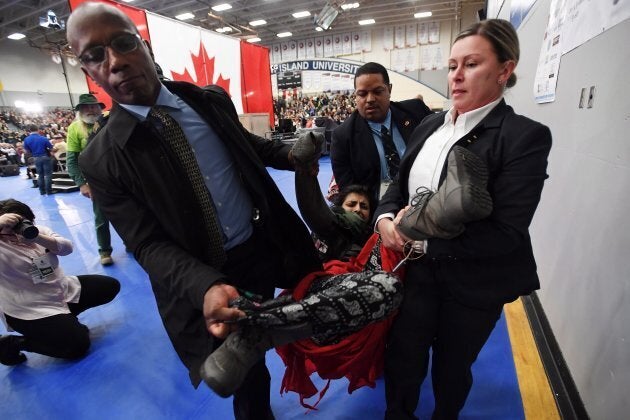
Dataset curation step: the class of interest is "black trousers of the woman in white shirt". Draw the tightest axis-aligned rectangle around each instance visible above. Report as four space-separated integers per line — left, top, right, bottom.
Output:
385 261 503 420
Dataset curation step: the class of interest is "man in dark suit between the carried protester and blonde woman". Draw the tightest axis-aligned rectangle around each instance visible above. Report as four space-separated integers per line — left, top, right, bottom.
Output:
330 62 431 205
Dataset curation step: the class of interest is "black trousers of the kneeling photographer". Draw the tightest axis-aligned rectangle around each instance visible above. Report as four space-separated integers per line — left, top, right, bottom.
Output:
5 274 120 359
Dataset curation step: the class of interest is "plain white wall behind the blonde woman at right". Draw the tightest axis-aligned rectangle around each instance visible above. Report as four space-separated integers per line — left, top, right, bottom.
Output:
502 0 630 420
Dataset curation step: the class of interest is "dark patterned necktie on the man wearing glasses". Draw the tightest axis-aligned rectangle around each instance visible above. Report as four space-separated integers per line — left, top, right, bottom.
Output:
148 107 226 269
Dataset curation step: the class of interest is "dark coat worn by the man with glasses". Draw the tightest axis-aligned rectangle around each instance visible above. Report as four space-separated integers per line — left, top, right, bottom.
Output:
79 82 321 385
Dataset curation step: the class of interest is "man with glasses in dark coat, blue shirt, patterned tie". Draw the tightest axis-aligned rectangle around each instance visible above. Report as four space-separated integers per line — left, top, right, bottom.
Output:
67 3 321 419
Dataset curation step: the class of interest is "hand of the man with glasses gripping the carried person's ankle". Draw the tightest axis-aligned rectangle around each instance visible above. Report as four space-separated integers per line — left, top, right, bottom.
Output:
203 284 245 338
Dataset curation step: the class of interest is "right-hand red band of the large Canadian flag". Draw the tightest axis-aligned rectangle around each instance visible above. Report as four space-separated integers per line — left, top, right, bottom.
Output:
241 41 274 127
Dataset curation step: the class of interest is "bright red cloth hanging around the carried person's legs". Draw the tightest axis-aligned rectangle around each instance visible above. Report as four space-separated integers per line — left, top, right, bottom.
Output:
276 233 402 409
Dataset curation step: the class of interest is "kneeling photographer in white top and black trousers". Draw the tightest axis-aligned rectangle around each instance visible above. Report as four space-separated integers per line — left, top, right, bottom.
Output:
0 199 120 365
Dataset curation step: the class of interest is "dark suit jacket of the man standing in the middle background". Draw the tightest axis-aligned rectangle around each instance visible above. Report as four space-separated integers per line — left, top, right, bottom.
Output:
330 99 432 197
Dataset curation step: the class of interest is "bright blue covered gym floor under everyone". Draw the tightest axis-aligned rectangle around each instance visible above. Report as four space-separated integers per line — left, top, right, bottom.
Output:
0 157 532 420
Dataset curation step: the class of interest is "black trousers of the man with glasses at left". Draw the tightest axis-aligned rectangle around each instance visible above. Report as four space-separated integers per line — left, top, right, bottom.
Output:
217 228 284 420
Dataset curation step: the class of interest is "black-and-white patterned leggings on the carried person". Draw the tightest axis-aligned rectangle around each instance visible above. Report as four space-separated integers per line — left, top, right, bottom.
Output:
232 271 402 344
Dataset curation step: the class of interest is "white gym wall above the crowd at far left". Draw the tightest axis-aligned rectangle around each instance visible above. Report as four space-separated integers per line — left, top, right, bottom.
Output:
0 38 87 107
